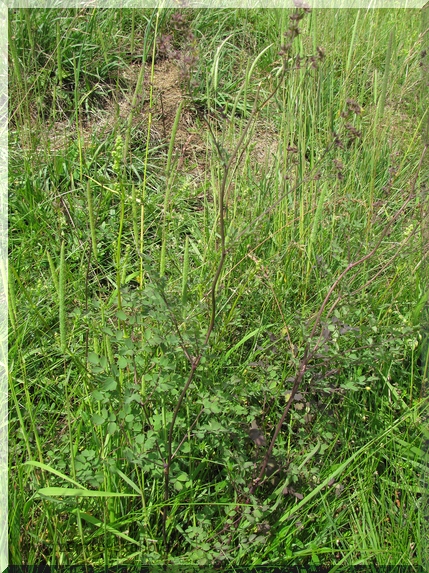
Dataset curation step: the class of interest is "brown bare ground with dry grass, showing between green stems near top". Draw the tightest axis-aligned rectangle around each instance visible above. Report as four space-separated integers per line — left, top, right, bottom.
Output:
37 56 278 178
